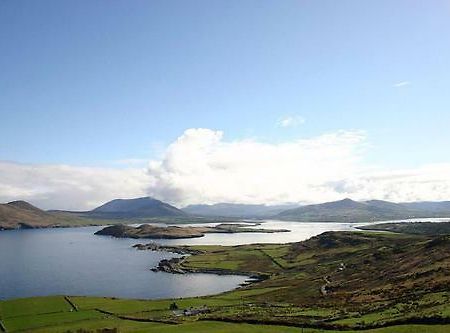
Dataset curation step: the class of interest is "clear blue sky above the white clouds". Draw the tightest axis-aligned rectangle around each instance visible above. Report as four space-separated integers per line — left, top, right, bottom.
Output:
0 0 450 208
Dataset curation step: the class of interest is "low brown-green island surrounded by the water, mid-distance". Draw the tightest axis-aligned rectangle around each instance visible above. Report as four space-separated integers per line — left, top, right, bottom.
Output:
95 223 289 239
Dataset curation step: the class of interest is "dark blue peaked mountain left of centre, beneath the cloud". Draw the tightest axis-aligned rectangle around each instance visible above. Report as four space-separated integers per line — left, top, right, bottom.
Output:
82 197 187 219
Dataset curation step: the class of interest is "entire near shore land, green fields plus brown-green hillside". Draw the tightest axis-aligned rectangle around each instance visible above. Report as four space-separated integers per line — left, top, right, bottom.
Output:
0 232 450 333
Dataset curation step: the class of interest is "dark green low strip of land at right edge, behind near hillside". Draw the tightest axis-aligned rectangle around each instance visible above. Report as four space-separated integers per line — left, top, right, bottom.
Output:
358 222 450 235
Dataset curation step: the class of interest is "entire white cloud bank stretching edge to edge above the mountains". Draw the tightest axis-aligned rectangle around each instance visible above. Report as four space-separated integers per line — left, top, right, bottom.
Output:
0 128 450 210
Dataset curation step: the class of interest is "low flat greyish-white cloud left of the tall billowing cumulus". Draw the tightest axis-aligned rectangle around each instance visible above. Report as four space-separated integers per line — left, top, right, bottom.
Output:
0 162 149 210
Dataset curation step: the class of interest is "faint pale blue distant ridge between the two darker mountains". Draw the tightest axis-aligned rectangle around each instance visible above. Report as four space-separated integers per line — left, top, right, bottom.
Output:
182 203 298 218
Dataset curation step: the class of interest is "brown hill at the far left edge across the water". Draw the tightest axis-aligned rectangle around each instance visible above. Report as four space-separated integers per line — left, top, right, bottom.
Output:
0 201 85 230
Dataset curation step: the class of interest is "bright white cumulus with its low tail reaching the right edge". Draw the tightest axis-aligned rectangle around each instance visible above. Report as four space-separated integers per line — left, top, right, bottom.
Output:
149 129 450 205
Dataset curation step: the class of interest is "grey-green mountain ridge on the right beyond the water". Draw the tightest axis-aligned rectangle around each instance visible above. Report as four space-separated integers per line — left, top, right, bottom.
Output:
276 199 450 222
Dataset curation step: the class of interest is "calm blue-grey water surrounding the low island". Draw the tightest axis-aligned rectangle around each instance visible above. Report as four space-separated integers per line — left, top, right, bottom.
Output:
0 221 353 299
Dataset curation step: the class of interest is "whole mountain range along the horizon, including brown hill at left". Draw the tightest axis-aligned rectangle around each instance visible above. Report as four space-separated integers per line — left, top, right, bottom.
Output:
0 197 450 230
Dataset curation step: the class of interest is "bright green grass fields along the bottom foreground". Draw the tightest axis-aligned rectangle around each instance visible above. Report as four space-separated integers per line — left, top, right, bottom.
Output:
0 290 450 333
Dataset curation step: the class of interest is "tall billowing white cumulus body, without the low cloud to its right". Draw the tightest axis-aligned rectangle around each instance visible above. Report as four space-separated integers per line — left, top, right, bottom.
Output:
149 129 365 204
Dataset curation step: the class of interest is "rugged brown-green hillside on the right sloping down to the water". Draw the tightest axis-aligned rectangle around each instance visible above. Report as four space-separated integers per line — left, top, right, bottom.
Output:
169 232 450 329
